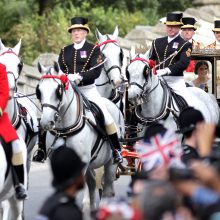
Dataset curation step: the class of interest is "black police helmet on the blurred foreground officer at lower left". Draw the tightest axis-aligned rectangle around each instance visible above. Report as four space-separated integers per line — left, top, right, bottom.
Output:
51 146 85 190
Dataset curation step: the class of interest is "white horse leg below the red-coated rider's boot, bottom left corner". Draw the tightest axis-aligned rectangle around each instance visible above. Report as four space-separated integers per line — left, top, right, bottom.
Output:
8 196 24 220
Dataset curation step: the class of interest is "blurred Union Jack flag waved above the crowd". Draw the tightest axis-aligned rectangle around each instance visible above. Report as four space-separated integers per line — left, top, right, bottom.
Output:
135 130 182 171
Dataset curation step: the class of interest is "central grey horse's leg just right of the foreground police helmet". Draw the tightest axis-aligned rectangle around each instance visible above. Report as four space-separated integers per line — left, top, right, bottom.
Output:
86 169 96 210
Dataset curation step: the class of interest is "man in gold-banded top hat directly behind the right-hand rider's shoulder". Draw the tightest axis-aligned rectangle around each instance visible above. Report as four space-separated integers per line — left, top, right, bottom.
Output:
181 17 202 72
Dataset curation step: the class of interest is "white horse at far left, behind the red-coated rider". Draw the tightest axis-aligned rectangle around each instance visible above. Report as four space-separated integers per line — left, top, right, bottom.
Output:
0 40 38 169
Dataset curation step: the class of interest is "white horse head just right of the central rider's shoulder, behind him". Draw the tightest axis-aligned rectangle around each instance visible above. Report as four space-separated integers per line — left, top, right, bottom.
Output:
95 26 123 87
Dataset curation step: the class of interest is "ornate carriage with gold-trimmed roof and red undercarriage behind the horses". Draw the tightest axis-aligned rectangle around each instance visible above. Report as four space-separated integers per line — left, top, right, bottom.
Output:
117 49 220 177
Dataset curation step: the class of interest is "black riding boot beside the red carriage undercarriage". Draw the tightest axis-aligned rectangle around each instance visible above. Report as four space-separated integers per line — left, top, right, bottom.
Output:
108 133 123 163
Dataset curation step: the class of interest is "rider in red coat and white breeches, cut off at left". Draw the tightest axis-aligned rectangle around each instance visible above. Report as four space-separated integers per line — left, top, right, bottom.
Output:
0 63 28 200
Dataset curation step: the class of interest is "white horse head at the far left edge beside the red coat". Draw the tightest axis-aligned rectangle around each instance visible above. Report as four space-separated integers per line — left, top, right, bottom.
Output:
0 40 23 91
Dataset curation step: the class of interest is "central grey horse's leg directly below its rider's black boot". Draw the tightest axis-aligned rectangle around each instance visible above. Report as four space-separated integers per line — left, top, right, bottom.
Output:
103 159 117 197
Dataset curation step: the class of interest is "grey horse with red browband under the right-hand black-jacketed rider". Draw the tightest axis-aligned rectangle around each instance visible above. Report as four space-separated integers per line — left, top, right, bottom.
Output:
126 49 219 129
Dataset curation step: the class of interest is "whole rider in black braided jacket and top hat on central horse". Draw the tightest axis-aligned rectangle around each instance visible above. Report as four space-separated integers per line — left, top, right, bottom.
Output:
58 17 122 163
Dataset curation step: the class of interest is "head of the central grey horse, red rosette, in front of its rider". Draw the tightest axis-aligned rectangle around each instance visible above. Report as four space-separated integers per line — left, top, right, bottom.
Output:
36 62 69 130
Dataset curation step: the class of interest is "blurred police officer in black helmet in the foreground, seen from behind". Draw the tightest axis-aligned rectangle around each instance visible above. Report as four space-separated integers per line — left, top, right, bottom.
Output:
36 146 85 220
